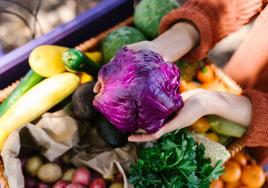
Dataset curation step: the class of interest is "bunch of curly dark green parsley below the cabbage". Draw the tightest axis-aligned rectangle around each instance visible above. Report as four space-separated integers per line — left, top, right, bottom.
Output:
129 129 223 188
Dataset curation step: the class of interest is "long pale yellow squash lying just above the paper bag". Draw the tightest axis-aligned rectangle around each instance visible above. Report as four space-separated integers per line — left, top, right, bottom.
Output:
0 73 80 150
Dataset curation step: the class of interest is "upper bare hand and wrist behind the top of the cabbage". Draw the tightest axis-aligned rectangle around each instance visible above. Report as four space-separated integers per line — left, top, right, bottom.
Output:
128 22 199 62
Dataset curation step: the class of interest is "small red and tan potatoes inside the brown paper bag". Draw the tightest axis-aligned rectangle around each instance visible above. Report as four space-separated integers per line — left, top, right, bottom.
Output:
22 155 123 188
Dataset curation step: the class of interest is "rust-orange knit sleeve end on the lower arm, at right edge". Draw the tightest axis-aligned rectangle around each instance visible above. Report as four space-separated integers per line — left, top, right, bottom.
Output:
242 89 268 147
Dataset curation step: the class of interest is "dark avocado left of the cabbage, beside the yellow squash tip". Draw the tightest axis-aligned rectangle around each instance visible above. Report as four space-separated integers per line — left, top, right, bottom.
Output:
72 81 97 120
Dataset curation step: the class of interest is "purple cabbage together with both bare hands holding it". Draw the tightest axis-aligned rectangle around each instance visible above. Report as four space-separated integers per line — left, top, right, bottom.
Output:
91 22 251 142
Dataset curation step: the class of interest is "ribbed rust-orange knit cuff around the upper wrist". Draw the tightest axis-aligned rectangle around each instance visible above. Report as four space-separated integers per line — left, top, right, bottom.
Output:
159 5 214 60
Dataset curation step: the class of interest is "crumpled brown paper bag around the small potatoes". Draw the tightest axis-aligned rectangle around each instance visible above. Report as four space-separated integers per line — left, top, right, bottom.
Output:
1 110 137 188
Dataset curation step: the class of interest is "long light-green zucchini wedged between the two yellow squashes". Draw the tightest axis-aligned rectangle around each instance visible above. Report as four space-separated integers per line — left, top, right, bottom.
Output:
0 70 43 117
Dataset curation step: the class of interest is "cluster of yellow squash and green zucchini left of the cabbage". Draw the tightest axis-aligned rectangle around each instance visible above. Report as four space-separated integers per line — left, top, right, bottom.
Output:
0 45 100 150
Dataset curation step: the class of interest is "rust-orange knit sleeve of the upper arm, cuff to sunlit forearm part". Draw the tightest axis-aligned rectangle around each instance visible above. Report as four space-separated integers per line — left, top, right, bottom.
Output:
159 0 265 59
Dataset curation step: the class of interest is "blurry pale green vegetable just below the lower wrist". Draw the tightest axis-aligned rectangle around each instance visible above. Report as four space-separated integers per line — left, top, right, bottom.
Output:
208 115 246 138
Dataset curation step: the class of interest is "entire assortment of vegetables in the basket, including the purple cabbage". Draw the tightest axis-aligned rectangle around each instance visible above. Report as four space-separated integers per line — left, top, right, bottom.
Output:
0 0 255 188
